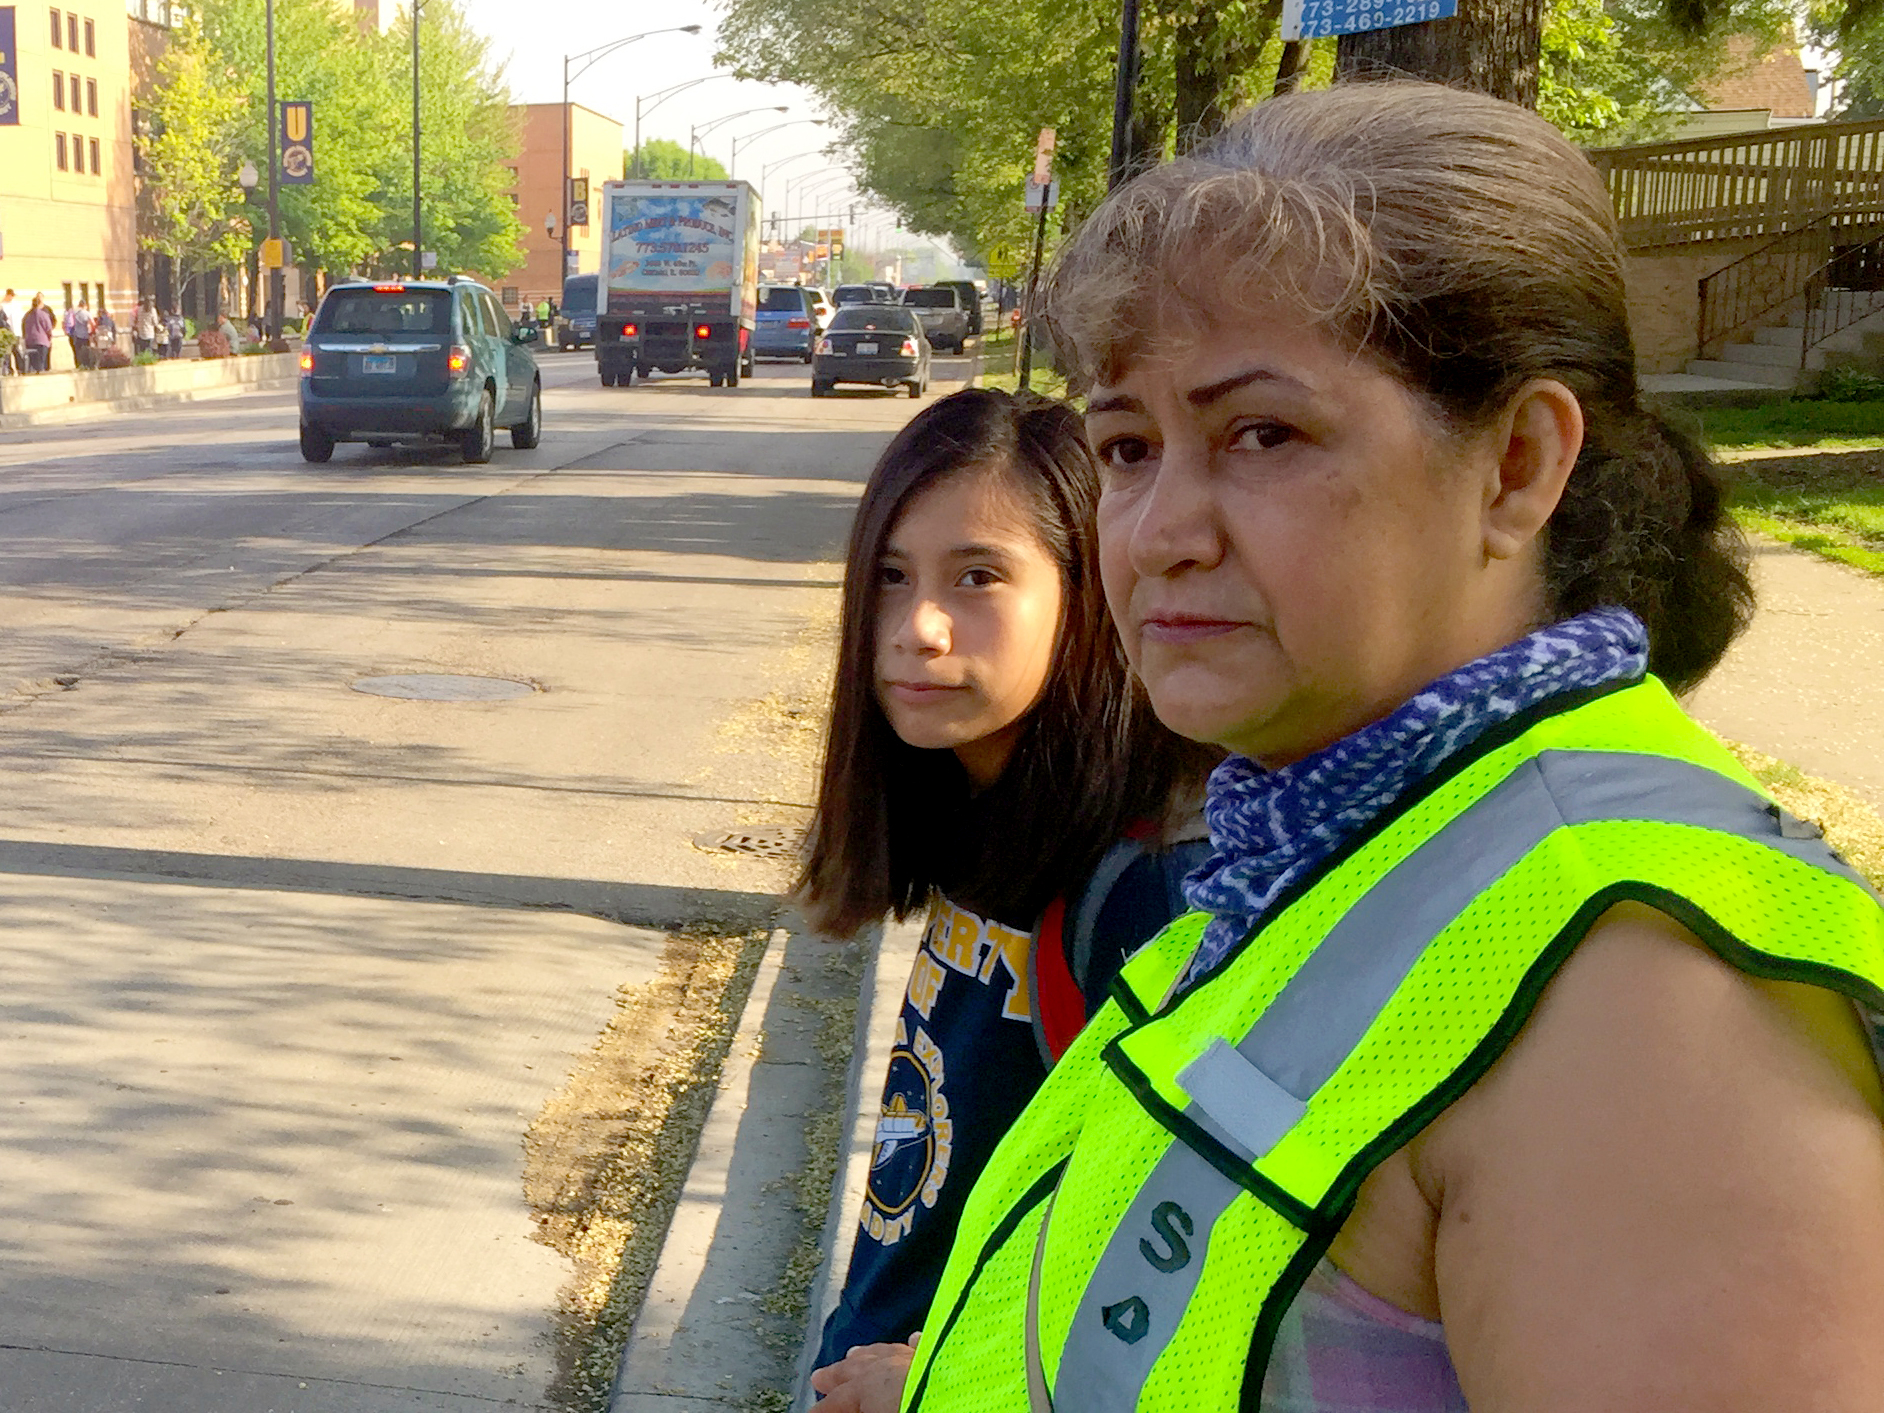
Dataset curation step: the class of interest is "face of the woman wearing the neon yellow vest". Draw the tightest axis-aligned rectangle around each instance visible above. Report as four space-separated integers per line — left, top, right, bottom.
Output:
1087 313 1541 767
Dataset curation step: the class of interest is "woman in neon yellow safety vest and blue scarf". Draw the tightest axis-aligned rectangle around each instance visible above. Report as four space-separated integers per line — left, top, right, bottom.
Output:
823 83 1884 1413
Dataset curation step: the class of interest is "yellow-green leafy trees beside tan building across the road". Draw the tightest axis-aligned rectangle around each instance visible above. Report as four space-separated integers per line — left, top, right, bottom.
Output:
141 0 522 279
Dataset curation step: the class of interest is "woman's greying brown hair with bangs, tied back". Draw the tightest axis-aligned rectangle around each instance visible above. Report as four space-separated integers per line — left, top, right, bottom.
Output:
1048 81 1752 690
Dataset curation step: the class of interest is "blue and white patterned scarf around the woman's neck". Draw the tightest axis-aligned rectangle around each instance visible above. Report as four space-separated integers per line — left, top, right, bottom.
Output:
1185 609 1649 978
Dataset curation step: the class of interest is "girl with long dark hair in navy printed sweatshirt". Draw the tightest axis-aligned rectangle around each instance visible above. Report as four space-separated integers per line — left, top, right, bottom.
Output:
799 388 1215 1364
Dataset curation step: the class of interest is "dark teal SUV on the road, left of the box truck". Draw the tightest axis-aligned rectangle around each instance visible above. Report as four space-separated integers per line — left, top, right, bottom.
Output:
300 275 543 462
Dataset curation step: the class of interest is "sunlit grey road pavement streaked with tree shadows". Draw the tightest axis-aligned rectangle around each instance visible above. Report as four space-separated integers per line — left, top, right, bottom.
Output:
0 354 966 1413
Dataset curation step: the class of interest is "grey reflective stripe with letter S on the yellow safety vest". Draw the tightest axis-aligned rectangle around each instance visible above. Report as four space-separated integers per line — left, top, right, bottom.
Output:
1029 750 1869 1413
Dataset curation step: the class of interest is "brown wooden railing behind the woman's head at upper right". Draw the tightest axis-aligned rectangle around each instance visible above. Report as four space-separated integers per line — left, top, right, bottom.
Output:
1588 119 1884 251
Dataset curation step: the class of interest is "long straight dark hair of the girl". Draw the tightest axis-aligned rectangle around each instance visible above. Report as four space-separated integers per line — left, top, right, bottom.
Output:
797 388 1208 936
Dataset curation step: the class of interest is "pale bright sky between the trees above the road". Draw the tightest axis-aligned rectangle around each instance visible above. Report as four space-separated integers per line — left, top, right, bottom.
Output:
448 0 911 248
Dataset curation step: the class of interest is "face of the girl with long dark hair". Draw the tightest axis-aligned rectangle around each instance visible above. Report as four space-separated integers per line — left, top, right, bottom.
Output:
876 471 1064 788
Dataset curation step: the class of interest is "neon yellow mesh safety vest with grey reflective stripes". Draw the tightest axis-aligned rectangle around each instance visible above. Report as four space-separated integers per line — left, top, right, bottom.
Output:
904 678 1884 1413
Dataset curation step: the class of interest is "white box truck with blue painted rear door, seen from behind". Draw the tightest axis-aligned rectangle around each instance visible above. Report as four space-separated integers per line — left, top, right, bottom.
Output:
595 181 759 388
